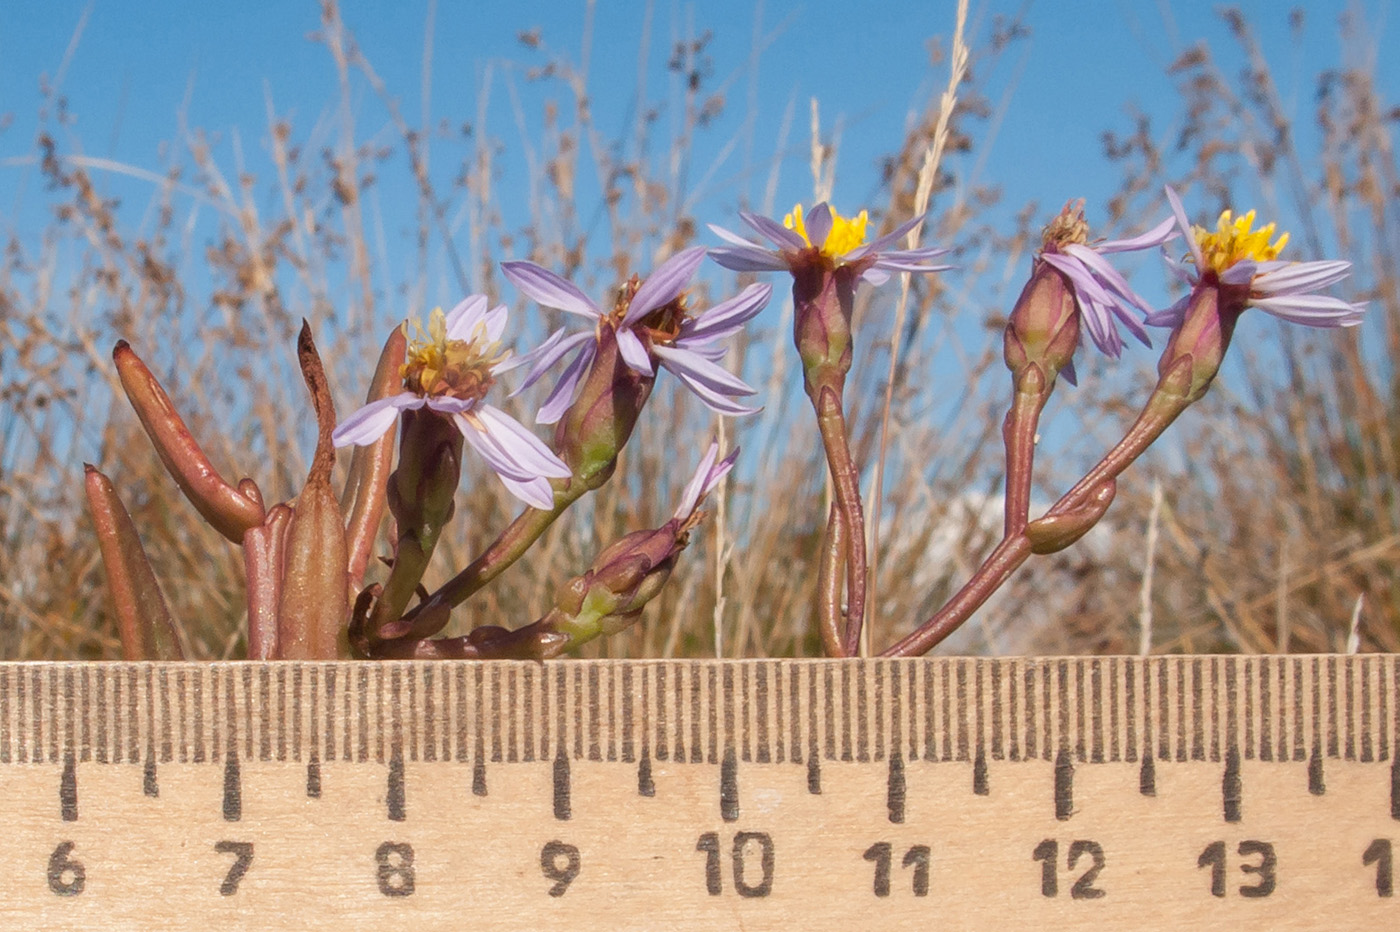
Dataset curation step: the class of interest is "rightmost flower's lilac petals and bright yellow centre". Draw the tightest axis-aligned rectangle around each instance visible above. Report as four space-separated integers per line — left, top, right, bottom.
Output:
1147 188 1366 327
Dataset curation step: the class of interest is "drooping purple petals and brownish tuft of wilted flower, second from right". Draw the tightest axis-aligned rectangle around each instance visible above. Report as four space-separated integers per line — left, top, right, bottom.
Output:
1040 202 1177 363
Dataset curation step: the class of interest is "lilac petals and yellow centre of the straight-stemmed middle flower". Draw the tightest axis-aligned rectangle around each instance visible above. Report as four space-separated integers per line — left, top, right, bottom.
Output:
710 202 952 285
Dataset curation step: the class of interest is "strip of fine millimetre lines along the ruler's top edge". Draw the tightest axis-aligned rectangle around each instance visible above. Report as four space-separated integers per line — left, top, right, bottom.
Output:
0 655 1400 766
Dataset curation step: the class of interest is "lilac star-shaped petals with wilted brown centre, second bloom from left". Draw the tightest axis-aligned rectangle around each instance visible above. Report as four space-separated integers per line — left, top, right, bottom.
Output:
501 248 771 424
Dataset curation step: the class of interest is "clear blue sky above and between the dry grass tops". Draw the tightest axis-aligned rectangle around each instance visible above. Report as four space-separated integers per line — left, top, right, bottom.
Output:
0 0 1400 478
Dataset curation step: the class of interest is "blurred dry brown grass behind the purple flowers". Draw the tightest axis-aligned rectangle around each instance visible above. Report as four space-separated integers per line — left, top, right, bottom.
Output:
0 0 1400 659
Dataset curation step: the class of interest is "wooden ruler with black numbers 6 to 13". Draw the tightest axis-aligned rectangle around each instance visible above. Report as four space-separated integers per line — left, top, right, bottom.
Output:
0 655 1400 932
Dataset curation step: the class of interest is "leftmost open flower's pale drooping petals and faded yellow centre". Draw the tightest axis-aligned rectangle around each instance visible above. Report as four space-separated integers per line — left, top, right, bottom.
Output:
332 295 571 511
